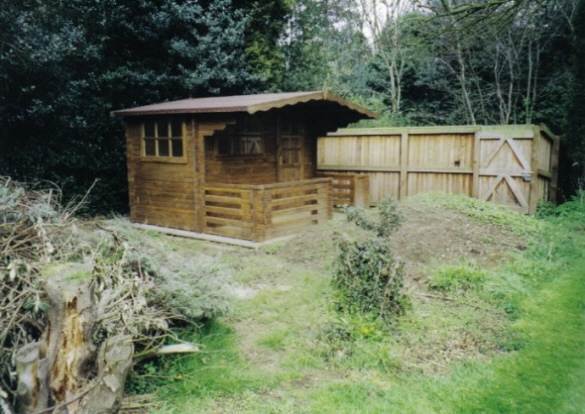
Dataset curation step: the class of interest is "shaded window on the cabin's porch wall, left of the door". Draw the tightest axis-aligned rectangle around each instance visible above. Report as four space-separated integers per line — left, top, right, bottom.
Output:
217 119 263 156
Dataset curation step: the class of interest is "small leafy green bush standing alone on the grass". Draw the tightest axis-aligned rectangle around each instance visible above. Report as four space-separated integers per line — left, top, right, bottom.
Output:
333 199 404 321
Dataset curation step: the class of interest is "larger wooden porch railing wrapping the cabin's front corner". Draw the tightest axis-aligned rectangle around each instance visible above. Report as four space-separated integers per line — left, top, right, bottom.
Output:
204 178 333 241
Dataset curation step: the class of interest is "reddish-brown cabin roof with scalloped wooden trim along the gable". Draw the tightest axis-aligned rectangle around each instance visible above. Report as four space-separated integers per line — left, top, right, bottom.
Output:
112 90 378 118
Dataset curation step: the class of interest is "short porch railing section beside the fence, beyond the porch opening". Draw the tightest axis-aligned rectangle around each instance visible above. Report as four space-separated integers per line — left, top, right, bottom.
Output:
319 171 370 207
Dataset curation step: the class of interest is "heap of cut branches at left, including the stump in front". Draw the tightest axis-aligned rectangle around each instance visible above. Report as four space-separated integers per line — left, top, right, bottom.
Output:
0 177 227 413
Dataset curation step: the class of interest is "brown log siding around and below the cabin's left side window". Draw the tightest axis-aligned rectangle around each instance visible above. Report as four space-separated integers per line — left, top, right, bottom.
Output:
126 122 195 230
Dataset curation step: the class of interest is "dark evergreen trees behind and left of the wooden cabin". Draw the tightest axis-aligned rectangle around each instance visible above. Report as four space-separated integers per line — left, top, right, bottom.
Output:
0 0 284 211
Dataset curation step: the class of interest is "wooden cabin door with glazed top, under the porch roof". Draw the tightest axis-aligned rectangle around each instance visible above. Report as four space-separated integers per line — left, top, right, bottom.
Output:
277 120 304 182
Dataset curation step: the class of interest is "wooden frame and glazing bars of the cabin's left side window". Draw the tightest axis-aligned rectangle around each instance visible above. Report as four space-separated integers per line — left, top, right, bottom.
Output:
140 118 187 164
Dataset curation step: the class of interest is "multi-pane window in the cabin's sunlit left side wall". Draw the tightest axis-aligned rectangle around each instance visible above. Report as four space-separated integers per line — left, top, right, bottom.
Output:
142 119 183 158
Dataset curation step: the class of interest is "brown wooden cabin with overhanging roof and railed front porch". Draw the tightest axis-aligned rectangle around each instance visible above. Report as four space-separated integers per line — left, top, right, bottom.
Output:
113 91 376 241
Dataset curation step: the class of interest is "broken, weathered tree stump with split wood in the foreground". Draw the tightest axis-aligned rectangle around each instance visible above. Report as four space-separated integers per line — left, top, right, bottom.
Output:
16 264 133 414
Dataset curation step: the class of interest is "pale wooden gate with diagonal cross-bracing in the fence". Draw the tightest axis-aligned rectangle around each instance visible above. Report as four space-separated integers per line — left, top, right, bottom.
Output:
477 132 536 213
